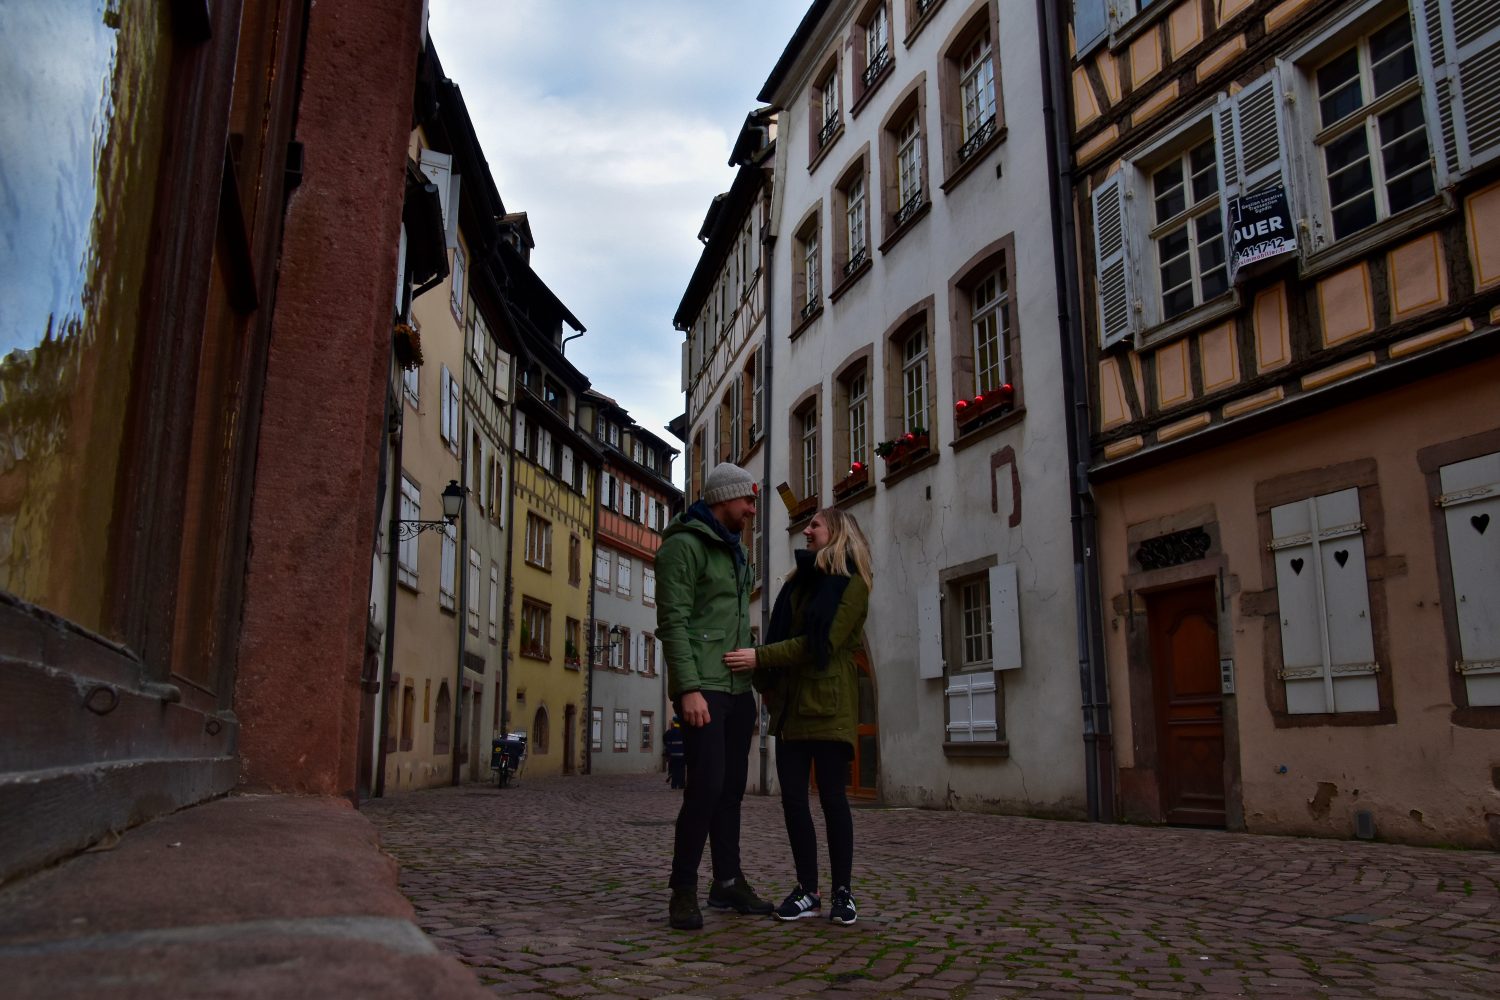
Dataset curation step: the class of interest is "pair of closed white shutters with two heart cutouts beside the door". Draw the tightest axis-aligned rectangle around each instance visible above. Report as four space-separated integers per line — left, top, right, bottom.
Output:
1271 487 1380 715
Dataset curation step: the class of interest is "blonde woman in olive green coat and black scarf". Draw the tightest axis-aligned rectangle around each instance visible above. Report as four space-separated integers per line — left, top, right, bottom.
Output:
725 507 872 924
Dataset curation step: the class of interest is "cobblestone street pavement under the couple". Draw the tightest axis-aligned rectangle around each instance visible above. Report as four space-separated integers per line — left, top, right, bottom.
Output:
365 777 1500 1000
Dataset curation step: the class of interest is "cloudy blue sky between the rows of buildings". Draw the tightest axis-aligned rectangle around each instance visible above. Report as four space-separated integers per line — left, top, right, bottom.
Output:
429 0 809 461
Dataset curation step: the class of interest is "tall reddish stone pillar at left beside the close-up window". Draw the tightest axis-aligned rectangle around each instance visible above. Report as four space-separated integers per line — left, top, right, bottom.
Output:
236 0 422 796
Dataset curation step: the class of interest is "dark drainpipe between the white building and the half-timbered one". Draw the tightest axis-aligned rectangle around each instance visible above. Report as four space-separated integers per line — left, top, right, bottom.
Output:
1037 0 1115 823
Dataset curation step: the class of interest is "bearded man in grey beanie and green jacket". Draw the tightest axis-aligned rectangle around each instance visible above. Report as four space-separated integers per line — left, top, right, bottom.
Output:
656 462 771 930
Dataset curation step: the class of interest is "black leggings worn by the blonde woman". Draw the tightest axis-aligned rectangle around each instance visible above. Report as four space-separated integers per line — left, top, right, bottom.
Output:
776 739 854 892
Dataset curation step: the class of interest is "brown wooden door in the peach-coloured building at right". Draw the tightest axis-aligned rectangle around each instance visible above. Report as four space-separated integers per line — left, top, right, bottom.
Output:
1146 583 1224 826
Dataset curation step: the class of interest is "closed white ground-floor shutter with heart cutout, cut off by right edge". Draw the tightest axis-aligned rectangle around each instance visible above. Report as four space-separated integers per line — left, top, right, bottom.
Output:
1439 451 1500 706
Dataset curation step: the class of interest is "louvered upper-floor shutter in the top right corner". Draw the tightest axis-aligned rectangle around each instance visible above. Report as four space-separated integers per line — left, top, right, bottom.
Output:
1416 0 1500 175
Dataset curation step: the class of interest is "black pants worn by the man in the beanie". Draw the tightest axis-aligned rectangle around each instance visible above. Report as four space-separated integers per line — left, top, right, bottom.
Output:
671 691 756 891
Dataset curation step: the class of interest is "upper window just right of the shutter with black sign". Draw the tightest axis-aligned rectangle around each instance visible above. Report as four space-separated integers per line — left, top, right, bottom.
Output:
1313 10 1436 240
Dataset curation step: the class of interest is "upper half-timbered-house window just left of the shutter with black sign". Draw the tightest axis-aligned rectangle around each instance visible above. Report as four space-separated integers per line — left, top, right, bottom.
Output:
1151 135 1229 319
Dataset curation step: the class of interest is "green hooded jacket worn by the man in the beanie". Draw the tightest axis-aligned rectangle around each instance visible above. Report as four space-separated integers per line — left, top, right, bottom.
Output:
656 504 752 699
